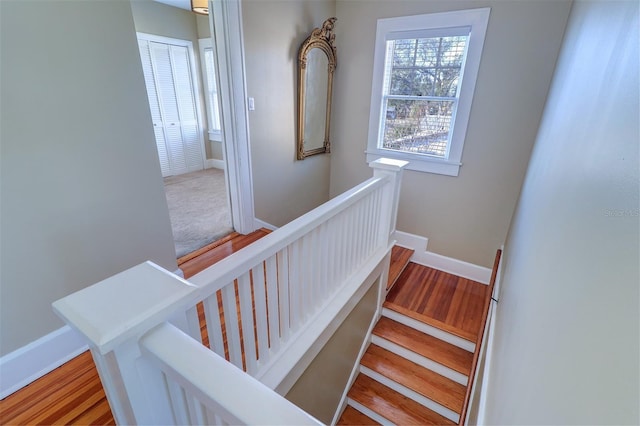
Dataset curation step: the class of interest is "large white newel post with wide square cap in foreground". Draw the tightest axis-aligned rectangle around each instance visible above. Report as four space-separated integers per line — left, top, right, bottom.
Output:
53 262 197 424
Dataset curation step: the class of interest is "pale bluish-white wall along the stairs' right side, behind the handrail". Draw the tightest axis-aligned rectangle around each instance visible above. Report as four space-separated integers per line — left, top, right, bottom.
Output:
486 1 640 424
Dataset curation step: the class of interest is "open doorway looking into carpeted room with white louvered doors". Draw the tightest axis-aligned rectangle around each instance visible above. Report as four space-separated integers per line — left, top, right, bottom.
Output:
138 29 233 258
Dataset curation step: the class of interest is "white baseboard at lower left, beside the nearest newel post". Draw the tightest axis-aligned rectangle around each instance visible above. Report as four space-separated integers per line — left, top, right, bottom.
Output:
0 325 89 399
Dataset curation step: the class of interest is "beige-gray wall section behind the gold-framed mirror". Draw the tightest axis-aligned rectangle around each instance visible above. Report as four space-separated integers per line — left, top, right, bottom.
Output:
242 0 336 226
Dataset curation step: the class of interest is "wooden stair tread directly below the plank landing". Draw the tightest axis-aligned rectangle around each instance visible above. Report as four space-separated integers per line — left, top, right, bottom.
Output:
373 317 473 376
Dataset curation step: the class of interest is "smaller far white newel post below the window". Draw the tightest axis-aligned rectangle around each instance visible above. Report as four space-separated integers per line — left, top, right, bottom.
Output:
369 158 409 244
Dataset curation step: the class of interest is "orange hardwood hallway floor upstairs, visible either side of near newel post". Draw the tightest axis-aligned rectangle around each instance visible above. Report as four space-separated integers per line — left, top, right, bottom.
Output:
0 229 270 425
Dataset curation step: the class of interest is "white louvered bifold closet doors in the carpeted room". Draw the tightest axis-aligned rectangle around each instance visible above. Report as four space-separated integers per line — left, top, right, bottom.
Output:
141 37 204 176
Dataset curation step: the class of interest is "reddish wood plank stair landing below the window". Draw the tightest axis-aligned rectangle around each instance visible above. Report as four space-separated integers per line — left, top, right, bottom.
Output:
385 263 490 343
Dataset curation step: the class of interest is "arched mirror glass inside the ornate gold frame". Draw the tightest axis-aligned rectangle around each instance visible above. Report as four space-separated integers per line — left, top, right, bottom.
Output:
303 49 329 151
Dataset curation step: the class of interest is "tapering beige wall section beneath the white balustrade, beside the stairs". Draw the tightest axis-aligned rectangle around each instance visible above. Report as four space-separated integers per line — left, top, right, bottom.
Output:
286 283 378 424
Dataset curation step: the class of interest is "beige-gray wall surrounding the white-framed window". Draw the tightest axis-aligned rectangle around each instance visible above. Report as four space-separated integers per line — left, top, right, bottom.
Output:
331 0 570 267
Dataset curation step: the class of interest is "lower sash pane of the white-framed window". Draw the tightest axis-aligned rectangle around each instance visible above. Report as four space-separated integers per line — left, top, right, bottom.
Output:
382 99 455 157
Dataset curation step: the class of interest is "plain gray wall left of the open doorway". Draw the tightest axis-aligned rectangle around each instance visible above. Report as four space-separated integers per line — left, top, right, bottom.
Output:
0 1 176 355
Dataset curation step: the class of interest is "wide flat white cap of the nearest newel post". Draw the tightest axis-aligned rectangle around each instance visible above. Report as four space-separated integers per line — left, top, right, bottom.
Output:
53 261 197 355
